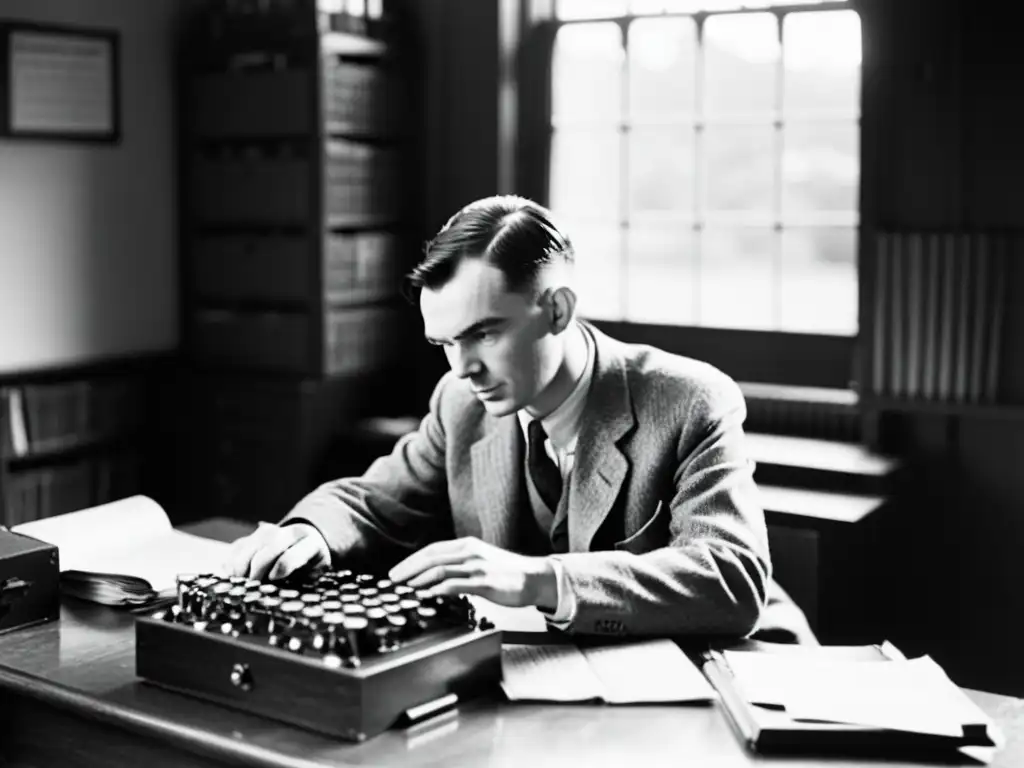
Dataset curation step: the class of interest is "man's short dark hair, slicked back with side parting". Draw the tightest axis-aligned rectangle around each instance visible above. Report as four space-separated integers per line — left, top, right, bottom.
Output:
407 195 574 298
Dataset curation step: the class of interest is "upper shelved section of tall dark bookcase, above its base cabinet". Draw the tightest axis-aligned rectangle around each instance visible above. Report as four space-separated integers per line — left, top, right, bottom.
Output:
182 2 412 378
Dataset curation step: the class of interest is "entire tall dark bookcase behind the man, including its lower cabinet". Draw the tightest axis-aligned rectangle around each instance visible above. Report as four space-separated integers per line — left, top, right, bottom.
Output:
177 0 419 519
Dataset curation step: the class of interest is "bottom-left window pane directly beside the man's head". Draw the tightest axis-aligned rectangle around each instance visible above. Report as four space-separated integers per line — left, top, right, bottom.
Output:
558 217 626 319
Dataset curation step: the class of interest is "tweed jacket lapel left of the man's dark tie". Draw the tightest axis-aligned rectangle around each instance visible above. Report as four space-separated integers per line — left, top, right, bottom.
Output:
470 416 522 549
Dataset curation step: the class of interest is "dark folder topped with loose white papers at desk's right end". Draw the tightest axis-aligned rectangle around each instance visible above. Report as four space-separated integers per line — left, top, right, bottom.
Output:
701 642 1002 757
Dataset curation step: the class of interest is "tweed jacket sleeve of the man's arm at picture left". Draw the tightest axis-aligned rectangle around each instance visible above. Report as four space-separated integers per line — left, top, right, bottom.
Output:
282 375 452 567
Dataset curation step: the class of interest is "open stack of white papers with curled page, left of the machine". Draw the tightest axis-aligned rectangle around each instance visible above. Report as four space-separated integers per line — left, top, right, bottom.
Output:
11 496 229 605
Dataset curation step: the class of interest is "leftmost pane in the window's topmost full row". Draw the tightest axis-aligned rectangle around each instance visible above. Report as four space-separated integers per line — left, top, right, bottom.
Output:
551 23 623 123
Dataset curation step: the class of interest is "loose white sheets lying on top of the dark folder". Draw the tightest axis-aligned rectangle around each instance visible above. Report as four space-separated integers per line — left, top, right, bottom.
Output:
724 651 989 737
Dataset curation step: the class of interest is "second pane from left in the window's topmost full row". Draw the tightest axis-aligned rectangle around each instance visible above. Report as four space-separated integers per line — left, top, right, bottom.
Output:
627 18 697 119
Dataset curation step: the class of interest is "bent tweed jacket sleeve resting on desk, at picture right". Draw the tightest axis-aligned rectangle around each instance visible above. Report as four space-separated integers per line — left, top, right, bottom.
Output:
559 376 771 637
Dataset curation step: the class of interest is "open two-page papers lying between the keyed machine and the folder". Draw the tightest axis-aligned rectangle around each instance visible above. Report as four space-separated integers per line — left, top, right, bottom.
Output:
502 640 717 703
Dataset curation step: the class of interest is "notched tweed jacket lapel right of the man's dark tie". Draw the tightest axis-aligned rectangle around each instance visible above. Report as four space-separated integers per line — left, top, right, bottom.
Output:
568 324 636 552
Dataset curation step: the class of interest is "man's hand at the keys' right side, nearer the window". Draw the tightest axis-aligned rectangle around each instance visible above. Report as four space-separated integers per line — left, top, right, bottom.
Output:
389 537 558 610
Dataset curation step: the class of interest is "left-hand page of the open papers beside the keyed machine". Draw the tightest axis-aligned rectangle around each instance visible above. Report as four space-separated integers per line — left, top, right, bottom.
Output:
502 645 603 701
